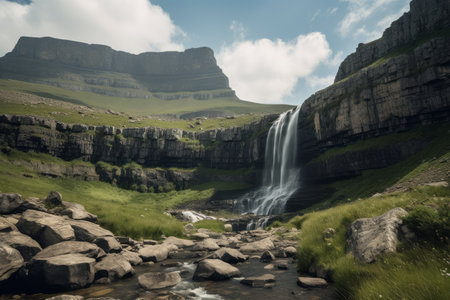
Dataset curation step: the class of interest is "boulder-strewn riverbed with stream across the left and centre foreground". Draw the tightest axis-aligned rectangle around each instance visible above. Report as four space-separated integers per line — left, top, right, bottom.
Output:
0 192 333 300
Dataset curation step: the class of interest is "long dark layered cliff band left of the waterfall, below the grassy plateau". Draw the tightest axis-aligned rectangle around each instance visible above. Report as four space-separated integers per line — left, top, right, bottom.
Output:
0 115 277 171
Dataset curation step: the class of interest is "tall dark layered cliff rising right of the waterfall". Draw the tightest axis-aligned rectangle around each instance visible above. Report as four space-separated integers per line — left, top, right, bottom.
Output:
299 0 450 182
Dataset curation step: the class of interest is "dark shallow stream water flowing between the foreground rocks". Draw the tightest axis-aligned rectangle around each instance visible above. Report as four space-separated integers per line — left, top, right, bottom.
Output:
0 259 335 300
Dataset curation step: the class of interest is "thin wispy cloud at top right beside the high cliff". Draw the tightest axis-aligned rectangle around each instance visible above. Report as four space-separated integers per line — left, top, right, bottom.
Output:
338 0 409 39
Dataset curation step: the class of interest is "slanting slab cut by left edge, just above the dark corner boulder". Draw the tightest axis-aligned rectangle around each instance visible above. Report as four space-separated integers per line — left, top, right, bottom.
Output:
0 231 42 261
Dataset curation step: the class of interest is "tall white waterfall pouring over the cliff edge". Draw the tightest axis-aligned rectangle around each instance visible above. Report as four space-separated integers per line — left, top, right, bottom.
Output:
238 108 300 215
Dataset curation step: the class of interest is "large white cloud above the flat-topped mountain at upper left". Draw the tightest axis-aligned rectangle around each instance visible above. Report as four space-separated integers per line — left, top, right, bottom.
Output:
0 0 184 55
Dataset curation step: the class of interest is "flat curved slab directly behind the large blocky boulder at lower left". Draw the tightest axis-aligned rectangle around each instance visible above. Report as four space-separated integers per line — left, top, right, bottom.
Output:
33 241 105 260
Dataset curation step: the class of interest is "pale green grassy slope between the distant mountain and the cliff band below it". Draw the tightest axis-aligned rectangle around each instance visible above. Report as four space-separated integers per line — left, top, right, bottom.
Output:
0 79 292 117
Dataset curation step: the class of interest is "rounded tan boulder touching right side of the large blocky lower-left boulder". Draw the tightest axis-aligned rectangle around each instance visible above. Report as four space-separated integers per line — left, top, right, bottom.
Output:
95 254 135 282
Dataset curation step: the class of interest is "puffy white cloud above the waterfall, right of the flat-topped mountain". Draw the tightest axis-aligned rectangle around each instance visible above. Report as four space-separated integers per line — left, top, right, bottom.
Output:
217 32 331 103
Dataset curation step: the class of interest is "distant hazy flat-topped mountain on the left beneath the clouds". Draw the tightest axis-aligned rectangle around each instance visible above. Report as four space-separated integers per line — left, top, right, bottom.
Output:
0 37 235 100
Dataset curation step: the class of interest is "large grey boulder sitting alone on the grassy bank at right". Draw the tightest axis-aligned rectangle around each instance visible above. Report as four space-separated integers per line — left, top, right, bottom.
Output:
347 207 408 263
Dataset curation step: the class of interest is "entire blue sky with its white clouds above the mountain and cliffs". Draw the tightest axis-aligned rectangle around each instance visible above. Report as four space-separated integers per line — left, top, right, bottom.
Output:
0 0 409 105
